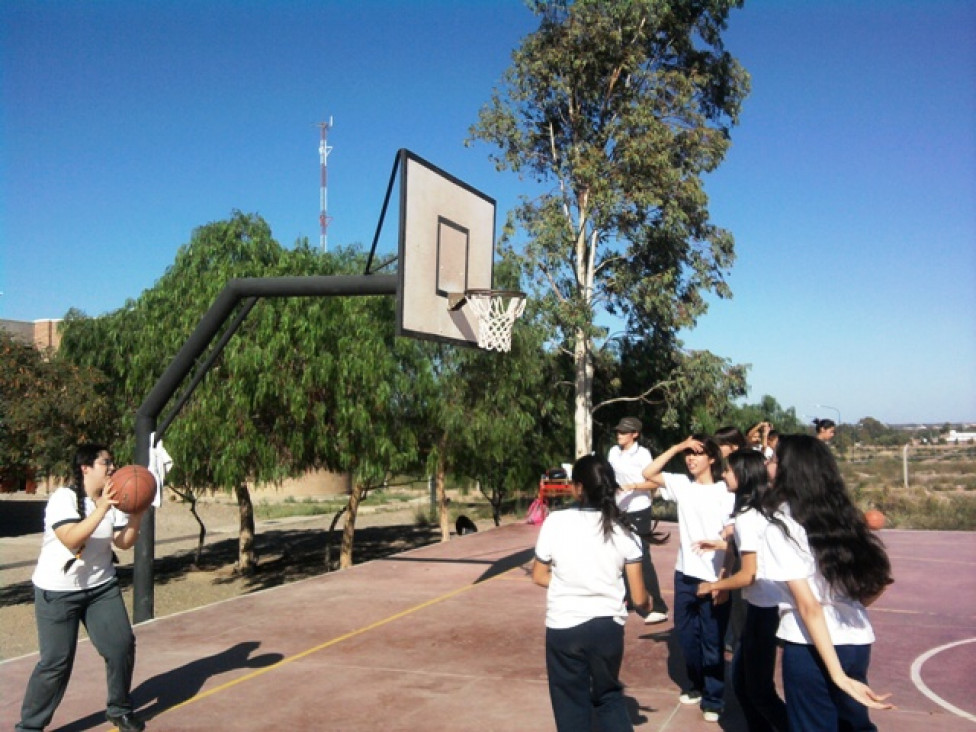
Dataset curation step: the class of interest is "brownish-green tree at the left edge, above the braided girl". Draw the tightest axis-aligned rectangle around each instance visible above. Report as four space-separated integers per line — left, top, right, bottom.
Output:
0 331 113 485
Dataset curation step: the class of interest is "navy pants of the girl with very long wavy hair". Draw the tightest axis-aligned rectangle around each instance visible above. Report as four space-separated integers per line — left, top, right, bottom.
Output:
783 643 878 732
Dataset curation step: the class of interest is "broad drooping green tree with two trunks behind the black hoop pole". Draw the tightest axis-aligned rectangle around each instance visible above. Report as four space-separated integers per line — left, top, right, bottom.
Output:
62 213 428 572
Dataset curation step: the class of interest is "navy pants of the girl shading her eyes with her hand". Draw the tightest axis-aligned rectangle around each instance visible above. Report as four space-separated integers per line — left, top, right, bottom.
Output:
674 572 730 712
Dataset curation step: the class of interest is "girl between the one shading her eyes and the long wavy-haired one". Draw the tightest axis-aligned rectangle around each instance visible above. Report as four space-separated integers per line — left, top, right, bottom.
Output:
696 449 787 732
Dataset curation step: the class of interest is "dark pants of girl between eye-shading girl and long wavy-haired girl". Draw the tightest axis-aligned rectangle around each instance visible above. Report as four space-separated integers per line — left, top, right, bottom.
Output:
732 602 787 732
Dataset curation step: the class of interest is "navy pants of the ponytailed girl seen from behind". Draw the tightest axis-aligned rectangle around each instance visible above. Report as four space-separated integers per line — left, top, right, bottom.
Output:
546 618 634 732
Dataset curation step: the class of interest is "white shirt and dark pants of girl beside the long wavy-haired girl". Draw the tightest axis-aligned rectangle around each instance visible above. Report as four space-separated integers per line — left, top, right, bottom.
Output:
732 508 787 732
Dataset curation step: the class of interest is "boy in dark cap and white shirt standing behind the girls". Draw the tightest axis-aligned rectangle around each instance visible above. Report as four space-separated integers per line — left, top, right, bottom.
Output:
607 417 668 625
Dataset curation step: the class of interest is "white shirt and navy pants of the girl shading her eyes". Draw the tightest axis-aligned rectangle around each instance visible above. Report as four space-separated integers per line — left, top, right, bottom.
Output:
659 473 735 713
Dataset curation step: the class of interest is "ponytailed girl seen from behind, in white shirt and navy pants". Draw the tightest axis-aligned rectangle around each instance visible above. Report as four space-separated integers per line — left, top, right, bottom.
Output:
532 455 649 732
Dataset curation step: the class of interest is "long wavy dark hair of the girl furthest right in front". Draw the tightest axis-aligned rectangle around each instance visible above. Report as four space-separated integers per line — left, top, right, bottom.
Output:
763 435 894 602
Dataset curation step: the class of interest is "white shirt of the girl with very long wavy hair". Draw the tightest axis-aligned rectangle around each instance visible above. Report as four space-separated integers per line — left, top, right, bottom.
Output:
764 506 874 646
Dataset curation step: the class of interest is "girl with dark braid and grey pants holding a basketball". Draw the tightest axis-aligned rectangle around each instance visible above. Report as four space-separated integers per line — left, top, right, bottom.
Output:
16 445 145 732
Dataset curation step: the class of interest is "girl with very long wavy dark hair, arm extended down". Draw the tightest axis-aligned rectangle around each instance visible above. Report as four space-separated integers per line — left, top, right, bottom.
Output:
762 435 893 732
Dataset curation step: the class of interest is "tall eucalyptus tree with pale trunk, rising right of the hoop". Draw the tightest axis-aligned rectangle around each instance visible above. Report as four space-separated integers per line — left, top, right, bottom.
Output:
471 0 748 455
